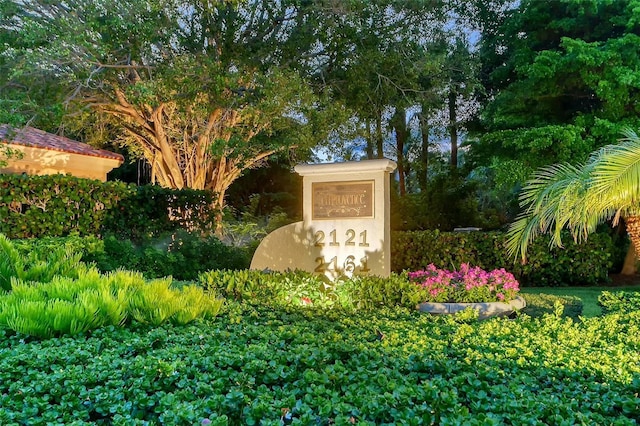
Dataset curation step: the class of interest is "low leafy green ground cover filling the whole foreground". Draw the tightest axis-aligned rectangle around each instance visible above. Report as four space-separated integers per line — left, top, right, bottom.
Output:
0 302 640 425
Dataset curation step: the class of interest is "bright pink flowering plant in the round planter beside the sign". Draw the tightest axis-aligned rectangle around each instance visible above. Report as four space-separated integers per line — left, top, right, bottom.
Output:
408 263 520 303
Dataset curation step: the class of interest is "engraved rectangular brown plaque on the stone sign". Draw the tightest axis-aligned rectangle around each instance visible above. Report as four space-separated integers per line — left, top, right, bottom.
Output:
311 180 374 220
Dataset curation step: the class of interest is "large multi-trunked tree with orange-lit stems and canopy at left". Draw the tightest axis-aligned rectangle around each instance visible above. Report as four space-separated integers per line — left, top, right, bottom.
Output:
2 0 344 223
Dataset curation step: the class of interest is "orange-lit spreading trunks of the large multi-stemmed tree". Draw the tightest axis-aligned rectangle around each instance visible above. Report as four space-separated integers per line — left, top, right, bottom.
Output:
99 90 277 233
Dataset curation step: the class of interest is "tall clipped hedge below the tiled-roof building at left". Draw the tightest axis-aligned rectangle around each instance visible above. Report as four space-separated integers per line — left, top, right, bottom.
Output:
0 174 215 240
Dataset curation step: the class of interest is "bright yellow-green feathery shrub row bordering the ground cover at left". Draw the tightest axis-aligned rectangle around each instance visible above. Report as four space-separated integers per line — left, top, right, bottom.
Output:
0 268 222 338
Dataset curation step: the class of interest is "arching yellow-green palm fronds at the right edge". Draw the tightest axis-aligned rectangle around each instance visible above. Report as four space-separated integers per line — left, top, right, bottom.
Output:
507 129 640 261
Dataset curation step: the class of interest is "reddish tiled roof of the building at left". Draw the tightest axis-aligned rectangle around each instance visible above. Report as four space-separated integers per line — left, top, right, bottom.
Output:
0 124 124 163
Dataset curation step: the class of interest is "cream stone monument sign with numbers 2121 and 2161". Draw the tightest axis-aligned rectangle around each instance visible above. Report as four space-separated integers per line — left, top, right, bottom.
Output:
251 159 396 280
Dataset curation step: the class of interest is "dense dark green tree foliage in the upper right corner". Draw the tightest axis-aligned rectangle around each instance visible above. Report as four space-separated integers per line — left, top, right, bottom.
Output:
473 0 640 178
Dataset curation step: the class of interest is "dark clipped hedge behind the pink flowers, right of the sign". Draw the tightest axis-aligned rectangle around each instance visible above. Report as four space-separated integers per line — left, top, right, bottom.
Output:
391 231 619 286
